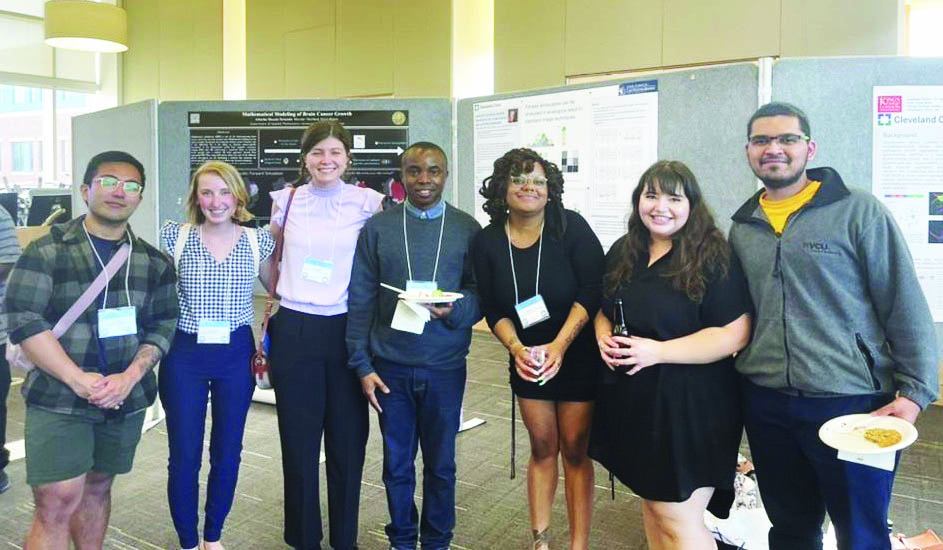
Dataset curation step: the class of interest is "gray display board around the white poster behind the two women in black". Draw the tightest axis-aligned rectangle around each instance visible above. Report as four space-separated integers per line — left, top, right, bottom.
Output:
453 63 758 231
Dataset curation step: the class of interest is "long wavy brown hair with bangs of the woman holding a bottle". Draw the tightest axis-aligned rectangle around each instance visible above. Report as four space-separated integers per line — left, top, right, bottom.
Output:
603 160 730 303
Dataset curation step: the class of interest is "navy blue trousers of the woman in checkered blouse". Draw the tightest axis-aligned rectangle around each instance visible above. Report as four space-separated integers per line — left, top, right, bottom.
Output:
158 325 255 548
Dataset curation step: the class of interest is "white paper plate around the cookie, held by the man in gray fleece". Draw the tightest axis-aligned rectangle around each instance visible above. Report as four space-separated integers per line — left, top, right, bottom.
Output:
819 414 917 454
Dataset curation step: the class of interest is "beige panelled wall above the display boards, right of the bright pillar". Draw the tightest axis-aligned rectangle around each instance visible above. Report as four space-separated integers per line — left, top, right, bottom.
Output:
494 0 902 92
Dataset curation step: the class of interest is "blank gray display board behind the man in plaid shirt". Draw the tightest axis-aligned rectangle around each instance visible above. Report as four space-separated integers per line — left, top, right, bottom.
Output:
72 100 161 246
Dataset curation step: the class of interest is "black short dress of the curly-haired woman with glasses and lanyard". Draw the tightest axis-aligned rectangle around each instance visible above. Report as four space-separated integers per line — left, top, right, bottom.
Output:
472 210 605 401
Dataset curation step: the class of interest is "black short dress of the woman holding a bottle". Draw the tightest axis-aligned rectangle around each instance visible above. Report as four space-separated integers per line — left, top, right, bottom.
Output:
590 237 752 517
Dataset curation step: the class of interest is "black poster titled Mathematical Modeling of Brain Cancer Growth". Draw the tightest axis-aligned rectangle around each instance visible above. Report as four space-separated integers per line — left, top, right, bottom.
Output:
189 110 409 225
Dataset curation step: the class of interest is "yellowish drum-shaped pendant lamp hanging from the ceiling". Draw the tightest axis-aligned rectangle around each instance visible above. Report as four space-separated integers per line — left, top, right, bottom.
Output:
45 0 128 53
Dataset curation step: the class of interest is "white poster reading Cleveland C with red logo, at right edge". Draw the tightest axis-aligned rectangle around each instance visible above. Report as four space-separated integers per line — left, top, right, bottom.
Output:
872 86 943 323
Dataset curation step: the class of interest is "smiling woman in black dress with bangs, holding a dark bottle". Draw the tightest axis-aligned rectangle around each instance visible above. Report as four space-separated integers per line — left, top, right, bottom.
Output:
590 161 751 550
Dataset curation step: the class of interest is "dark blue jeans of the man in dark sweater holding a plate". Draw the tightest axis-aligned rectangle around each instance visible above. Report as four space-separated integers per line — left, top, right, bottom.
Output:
375 359 466 550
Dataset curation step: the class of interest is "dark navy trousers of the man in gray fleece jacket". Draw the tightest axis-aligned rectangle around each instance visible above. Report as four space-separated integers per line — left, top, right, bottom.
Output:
741 380 900 550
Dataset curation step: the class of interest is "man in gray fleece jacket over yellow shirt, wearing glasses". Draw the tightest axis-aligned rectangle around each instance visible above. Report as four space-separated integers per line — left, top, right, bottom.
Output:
730 103 939 550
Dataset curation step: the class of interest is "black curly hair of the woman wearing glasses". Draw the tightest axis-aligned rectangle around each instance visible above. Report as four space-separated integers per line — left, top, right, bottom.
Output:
478 148 566 239
